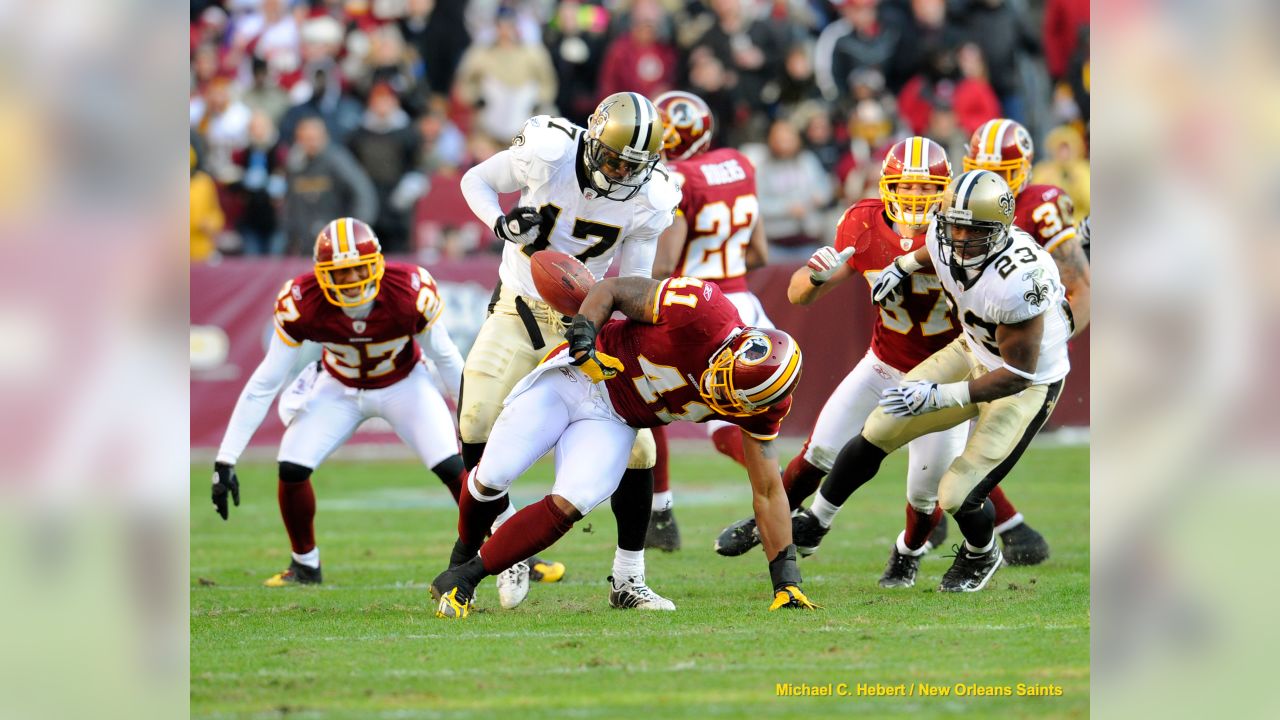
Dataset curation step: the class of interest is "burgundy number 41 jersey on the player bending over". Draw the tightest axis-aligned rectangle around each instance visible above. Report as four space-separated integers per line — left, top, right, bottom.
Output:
596 278 791 439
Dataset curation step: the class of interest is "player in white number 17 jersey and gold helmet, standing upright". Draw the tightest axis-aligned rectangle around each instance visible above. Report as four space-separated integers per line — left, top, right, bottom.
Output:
452 92 680 607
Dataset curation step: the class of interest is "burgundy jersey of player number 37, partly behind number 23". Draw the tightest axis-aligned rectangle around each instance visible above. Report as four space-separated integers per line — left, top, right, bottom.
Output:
836 199 959 373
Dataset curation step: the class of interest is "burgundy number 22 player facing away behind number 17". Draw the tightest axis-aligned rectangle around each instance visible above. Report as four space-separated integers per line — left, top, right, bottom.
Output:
645 91 773 552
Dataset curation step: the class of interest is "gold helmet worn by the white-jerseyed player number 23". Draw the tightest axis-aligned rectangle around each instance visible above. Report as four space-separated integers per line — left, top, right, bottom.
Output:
937 170 1014 284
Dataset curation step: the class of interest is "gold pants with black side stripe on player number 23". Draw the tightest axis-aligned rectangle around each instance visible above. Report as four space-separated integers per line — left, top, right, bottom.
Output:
863 336 1062 514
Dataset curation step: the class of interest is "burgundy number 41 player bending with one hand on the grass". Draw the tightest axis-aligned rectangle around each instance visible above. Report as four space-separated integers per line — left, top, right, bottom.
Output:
431 278 815 618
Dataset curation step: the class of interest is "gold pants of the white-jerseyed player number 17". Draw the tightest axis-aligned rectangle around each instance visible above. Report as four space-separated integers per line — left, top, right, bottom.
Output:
458 287 658 469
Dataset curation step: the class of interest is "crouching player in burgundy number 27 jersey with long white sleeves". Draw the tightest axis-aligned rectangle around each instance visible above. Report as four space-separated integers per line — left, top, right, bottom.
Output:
212 218 466 587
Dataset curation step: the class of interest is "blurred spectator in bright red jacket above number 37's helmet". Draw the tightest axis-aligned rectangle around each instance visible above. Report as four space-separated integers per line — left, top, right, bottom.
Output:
897 44 1000 135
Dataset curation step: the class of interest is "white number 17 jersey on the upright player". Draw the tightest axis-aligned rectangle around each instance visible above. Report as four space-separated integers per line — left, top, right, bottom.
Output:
498 115 680 299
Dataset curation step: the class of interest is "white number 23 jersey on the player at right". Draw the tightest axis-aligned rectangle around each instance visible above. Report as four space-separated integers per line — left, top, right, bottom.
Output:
925 219 1071 383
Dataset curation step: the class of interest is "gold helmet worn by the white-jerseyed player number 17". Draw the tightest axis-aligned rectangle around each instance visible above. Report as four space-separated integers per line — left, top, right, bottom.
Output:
584 92 663 200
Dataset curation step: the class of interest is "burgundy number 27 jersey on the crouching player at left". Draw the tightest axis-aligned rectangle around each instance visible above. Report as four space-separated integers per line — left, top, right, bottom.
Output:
275 263 444 389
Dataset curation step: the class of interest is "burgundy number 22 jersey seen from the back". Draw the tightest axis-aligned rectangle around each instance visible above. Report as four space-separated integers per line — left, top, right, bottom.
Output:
671 147 760 292
